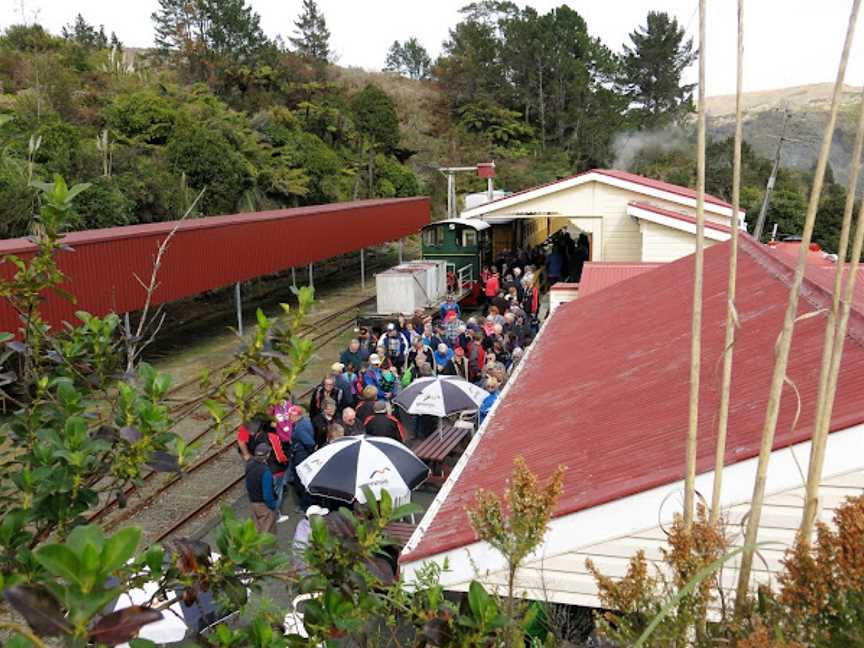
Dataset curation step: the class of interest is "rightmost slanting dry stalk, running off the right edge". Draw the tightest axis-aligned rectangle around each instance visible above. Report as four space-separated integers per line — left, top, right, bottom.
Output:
799 88 864 544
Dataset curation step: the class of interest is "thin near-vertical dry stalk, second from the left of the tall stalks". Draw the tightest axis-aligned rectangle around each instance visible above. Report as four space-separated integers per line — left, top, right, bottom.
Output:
711 0 744 524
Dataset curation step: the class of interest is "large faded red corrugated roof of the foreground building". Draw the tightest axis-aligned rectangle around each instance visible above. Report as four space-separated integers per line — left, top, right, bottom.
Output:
403 235 864 562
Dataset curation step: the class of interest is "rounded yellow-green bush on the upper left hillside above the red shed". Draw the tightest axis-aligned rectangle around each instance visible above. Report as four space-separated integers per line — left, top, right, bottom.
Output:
105 90 177 144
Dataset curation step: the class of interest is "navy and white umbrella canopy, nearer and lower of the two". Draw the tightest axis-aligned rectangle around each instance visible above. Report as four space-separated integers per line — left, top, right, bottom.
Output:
297 435 429 502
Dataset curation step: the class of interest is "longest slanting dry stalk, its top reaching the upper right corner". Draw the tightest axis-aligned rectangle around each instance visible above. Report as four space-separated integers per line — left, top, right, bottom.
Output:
735 0 861 614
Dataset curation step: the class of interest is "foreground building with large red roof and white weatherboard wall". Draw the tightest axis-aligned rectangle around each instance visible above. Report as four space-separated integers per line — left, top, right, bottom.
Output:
401 235 864 605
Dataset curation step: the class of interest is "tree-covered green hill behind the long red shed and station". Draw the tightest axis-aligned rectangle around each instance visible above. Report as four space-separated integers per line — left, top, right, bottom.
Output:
0 0 851 253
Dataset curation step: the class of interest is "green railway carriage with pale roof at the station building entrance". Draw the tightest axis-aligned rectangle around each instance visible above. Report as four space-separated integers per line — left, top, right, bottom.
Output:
421 218 492 283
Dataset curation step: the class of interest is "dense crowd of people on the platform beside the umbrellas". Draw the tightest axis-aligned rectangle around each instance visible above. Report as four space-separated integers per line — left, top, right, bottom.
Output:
237 246 545 532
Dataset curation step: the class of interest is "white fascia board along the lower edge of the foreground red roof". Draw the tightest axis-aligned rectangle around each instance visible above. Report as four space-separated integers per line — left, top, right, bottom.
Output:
401 424 864 588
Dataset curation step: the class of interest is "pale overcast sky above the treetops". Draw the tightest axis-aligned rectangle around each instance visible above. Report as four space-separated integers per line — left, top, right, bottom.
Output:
0 0 864 95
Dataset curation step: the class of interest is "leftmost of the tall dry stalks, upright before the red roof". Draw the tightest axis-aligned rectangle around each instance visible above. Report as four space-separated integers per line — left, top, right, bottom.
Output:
684 0 705 529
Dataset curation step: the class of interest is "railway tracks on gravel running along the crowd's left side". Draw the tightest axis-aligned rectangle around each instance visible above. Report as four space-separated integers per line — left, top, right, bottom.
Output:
90 298 373 542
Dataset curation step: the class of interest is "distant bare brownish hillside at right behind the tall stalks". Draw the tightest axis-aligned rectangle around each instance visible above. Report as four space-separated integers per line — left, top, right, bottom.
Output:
707 83 861 183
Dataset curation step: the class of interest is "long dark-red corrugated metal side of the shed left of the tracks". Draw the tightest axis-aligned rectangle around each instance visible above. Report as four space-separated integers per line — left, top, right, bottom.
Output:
0 198 430 331
